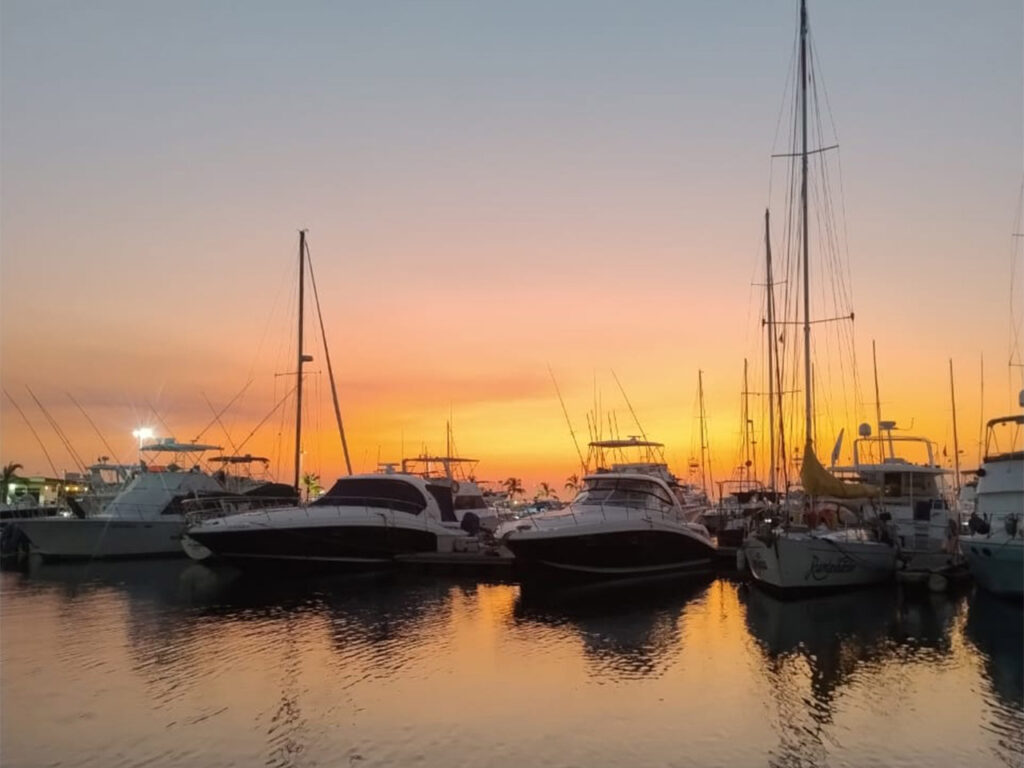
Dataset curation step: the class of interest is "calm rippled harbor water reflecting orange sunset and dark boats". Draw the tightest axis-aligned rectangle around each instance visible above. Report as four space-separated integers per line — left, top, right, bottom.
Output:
0 560 1024 768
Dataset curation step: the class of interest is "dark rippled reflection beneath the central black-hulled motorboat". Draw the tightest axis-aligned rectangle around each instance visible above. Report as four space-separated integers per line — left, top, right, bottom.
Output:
513 577 708 679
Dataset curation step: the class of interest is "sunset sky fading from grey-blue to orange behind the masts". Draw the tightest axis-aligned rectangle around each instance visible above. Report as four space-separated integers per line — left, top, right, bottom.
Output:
0 0 1024 487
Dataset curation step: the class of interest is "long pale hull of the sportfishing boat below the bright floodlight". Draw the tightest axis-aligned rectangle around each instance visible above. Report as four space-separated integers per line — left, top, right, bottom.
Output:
18 515 185 559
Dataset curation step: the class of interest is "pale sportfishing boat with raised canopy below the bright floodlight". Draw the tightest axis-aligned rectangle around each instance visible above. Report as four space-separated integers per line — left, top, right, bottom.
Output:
17 437 223 560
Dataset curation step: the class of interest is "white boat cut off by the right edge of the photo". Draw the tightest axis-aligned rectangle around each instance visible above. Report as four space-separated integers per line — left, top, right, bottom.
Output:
959 403 1024 599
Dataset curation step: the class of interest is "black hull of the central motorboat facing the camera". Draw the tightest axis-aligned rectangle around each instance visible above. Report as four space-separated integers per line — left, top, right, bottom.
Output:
506 525 715 579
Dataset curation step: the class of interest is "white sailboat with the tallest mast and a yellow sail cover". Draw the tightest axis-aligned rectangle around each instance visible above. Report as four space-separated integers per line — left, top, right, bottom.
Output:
743 0 897 594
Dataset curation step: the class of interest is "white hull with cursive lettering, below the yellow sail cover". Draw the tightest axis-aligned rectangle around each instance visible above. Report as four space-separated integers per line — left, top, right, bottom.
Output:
743 531 896 592
